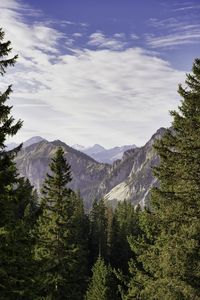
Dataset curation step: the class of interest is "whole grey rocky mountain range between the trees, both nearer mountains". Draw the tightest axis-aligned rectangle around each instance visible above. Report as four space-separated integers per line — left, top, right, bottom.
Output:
12 128 165 210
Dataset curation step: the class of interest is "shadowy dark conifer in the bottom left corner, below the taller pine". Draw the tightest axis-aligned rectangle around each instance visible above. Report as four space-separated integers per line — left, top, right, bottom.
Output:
0 178 37 300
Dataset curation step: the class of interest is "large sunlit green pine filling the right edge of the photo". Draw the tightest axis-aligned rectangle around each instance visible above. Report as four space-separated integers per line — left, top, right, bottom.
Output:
126 59 200 300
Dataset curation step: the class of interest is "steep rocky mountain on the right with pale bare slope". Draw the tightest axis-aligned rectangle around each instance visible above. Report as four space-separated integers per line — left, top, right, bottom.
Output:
105 128 165 207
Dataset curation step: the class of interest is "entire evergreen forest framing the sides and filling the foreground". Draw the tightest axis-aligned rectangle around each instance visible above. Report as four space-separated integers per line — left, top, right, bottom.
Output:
0 29 200 300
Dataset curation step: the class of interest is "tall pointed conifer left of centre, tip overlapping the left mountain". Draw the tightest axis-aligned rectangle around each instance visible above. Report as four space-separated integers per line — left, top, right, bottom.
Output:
35 148 87 300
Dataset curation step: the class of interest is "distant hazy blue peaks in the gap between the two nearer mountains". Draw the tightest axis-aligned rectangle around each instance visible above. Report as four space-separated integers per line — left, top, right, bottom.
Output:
72 144 136 164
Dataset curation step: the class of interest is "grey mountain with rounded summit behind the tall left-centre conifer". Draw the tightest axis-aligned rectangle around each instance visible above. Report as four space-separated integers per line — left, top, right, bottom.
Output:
16 140 109 208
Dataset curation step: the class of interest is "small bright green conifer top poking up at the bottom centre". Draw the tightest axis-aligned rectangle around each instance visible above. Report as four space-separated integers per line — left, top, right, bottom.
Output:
86 257 120 300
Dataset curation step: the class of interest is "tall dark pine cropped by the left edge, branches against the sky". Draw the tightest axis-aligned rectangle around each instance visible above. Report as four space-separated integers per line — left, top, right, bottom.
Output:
0 28 22 226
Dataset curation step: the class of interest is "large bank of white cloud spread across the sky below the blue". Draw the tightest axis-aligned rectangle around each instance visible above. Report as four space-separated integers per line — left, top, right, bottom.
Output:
0 0 184 146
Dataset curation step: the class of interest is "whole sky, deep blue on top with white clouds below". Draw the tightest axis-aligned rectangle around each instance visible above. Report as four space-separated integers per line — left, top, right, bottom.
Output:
0 0 200 148
